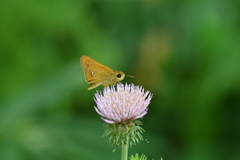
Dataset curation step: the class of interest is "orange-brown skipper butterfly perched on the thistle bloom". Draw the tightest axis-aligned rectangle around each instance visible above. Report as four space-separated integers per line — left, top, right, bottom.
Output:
80 55 133 90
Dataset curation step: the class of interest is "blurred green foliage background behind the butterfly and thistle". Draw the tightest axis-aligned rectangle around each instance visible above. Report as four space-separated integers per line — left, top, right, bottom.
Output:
0 0 240 160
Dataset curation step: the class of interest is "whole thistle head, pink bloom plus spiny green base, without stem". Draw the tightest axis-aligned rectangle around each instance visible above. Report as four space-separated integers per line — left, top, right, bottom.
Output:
94 84 152 147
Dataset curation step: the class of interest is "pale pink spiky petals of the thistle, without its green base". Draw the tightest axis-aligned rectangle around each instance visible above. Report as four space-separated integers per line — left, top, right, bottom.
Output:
94 84 152 124
